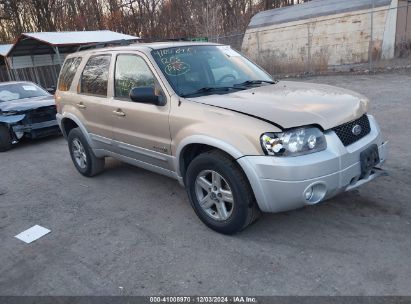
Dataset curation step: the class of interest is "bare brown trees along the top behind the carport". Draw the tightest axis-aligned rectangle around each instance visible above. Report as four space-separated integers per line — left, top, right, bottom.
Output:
0 0 309 43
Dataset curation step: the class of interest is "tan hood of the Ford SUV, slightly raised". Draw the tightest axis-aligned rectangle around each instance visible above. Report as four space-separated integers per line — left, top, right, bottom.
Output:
189 81 368 130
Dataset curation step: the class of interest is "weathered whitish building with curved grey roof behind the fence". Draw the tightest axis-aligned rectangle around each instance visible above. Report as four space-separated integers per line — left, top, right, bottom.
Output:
242 0 411 73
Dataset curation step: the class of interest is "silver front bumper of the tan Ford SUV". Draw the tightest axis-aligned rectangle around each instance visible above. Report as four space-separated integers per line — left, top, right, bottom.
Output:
238 115 388 212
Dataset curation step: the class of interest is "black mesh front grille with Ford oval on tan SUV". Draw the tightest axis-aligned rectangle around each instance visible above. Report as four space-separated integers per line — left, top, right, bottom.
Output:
331 114 371 146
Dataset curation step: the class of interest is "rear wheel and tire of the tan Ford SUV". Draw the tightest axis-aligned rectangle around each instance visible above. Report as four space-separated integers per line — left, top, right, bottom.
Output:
67 128 105 177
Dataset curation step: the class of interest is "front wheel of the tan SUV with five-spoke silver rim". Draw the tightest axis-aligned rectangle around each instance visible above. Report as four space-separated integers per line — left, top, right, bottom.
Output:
185 150 260 234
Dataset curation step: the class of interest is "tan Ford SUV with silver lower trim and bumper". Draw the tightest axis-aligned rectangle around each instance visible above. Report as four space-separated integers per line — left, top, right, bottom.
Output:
56 42 387 234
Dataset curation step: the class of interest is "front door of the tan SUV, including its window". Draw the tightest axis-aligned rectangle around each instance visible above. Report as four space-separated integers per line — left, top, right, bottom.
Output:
111 54 173 170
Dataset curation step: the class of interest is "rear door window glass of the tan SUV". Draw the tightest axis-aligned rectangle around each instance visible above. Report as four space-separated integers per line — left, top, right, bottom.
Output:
80 55 111 96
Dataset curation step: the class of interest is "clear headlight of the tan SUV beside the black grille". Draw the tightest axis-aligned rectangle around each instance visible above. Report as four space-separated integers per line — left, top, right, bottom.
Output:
260 127 327 156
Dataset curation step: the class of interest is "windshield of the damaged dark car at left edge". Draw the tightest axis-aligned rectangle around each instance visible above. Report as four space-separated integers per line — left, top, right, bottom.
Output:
0 83 50 102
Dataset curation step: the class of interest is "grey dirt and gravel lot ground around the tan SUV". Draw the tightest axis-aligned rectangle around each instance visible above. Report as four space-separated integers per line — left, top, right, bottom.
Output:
0 71 411 295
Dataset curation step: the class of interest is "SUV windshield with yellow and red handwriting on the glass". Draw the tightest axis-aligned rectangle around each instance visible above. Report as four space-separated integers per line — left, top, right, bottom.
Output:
151 45 274 96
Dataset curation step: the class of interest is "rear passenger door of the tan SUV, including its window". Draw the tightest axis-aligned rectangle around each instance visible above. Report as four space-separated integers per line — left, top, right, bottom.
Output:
75 54 113 149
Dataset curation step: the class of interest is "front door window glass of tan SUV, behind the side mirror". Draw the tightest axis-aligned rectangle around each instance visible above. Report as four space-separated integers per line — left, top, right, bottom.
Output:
114 55 155 99
